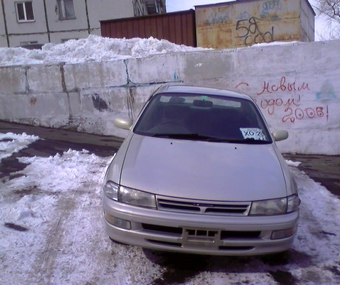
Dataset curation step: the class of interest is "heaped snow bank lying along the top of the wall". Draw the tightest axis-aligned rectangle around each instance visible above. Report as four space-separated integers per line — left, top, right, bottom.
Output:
0 35 207 66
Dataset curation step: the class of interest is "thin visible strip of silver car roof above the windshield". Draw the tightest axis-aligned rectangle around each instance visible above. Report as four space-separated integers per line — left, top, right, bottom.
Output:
154 84 252 100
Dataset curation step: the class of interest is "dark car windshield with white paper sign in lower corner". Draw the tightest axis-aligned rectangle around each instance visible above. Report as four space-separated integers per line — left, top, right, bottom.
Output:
133 93 272 144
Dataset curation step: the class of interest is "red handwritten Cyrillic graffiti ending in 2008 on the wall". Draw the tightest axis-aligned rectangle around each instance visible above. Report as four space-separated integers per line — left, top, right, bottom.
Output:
235 76 328 123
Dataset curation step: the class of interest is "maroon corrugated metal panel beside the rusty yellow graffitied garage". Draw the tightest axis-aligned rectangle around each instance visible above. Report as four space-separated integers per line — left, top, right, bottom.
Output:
100 10 197 47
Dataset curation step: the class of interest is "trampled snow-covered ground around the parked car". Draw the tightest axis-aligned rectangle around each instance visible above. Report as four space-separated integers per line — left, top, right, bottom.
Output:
0 133 340 285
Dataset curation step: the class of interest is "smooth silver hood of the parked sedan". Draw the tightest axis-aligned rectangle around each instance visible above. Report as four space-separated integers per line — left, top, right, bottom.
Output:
120 134 287 201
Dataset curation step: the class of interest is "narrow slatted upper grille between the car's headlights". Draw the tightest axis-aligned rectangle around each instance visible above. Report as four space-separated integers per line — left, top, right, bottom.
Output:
157 197 250 216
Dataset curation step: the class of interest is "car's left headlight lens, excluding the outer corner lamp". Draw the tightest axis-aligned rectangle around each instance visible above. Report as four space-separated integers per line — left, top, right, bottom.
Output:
118 186 156 209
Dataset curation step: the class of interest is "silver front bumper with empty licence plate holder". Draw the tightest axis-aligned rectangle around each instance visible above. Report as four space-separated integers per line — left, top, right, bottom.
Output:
103 195 299 256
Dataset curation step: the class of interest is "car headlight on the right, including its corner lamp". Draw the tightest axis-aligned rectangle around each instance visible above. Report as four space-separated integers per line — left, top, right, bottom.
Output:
249 195 300 216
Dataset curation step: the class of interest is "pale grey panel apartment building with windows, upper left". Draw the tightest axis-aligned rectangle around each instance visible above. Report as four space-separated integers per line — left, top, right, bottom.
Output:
0 0 166 47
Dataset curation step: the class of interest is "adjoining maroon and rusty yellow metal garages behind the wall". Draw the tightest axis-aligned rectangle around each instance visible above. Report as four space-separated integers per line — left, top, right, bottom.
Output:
101 0 315 49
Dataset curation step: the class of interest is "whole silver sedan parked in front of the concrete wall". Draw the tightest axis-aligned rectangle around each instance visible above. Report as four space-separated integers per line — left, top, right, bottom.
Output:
103 85 300 256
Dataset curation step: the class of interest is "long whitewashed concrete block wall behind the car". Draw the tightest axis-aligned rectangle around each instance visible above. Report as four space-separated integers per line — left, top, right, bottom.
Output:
0 41 340 154
